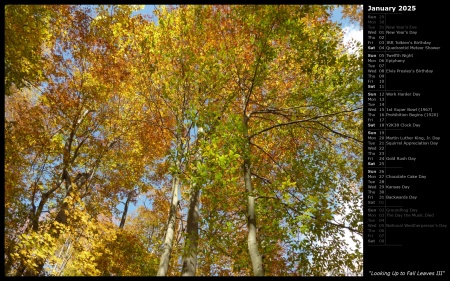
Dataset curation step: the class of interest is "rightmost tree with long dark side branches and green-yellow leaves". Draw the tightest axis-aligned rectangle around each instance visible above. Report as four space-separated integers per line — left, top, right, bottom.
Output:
172 6 362 275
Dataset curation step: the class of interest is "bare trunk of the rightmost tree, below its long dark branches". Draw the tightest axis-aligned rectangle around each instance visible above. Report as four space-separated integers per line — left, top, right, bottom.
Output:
243 116 264 276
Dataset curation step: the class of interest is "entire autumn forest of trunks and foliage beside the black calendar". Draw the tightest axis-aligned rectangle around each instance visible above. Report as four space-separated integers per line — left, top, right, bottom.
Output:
4 5 363 276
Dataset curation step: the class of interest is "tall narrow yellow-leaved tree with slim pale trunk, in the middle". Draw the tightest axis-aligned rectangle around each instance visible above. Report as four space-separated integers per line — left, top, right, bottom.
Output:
132 6 236 275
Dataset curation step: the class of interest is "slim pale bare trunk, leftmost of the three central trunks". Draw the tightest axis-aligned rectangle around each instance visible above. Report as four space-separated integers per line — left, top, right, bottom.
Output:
156 174 180 276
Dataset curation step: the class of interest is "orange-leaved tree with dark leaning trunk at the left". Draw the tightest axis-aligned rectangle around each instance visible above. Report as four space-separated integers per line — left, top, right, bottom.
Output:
6 6 170 275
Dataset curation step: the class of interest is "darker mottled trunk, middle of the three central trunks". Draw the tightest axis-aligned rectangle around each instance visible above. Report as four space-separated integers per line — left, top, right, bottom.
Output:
181 184 200 276
